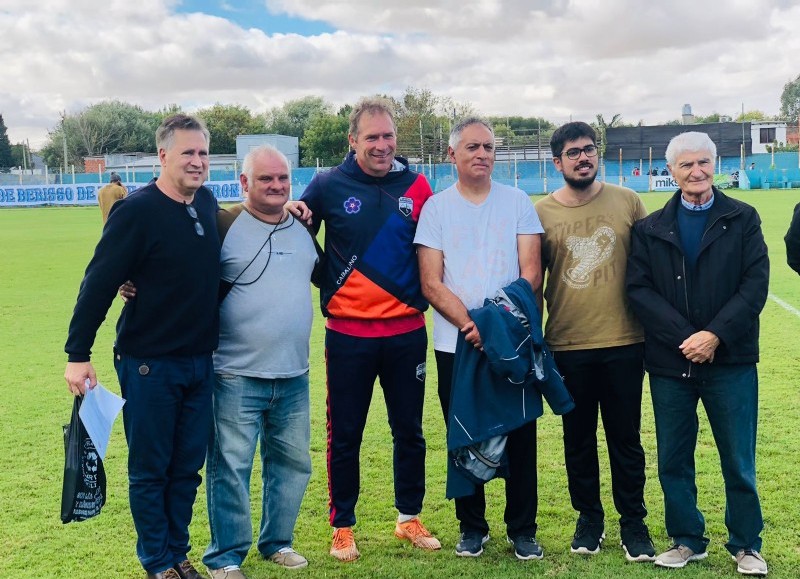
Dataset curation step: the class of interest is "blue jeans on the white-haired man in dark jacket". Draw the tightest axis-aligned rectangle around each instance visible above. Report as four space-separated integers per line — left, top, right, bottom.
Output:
650 364 764 554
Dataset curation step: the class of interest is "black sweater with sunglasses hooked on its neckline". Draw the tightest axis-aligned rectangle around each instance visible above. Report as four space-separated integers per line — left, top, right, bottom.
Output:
64 183 220 362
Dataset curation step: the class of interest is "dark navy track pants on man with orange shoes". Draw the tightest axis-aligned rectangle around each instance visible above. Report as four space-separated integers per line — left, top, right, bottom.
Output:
325 328 428 527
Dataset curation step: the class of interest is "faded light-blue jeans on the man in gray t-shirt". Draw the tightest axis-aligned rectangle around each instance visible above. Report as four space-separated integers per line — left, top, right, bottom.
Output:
203 373 311 569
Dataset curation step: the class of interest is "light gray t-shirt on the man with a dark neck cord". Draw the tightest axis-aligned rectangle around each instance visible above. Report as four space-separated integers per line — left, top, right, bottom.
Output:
214 211 317 378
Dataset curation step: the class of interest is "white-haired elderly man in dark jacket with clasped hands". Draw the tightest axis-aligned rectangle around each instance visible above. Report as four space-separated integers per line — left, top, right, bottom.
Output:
626 132 769 575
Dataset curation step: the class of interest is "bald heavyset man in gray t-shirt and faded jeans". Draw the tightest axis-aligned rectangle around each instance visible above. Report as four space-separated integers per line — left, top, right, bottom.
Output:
203 147 317 578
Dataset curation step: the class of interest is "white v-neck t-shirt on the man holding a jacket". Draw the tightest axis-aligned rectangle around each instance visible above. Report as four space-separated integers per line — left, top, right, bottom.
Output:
414 181 544 352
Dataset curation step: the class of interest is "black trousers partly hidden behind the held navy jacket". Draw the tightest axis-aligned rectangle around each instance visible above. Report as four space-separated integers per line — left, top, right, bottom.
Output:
434 350 539 537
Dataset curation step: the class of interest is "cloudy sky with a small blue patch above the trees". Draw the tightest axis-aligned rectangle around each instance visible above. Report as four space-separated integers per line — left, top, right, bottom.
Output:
0 0 800 148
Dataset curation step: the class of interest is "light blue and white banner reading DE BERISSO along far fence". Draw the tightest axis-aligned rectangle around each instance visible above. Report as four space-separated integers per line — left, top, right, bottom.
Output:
0 181 243 207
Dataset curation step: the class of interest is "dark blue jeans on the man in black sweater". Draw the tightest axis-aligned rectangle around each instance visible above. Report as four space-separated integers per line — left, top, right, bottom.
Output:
114 354 214 573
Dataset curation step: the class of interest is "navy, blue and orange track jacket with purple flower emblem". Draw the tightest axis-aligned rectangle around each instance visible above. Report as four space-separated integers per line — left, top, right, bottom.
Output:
301 151 433 326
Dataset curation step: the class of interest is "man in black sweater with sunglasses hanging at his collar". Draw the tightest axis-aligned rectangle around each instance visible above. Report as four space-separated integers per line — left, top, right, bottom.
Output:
64 114 220 579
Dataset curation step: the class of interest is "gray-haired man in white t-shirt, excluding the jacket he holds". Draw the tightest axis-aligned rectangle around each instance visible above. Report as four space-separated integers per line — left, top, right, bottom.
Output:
414 117 543 559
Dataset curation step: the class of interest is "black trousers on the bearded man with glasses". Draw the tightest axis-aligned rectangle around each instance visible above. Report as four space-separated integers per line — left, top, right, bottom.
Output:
553 344 647 525
